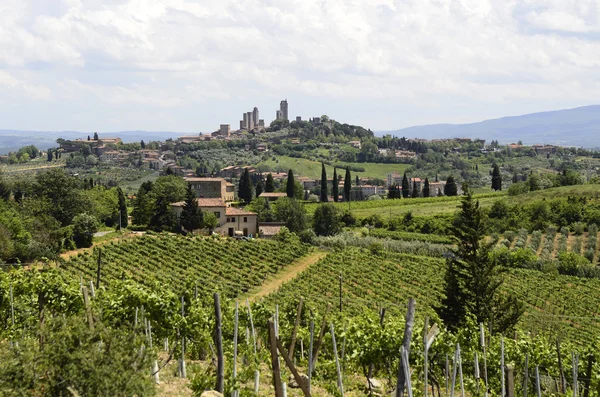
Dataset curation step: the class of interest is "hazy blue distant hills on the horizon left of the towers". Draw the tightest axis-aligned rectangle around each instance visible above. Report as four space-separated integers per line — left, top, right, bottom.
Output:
0 130 188 154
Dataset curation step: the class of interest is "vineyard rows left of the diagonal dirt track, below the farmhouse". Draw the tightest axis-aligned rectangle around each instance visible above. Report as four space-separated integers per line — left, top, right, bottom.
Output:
61 234 309 297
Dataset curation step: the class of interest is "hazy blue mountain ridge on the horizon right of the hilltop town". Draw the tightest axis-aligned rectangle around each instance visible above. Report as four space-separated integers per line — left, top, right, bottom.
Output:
375 105 600 148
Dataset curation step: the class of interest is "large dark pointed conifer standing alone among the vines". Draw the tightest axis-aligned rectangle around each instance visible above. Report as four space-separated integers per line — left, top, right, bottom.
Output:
438 188 523 333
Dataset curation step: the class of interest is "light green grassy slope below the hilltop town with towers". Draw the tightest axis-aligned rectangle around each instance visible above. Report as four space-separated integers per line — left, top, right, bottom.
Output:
256 156 409 179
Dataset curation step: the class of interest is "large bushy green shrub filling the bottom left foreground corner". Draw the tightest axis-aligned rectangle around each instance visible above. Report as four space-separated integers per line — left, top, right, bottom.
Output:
0 316 155 397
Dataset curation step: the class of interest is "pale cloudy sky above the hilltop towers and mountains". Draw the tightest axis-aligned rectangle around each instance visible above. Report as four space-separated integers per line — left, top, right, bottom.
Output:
0 0 600 132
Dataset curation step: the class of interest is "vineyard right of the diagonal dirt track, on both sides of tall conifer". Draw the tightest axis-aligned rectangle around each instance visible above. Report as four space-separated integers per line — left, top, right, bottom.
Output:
266 248 600 345
